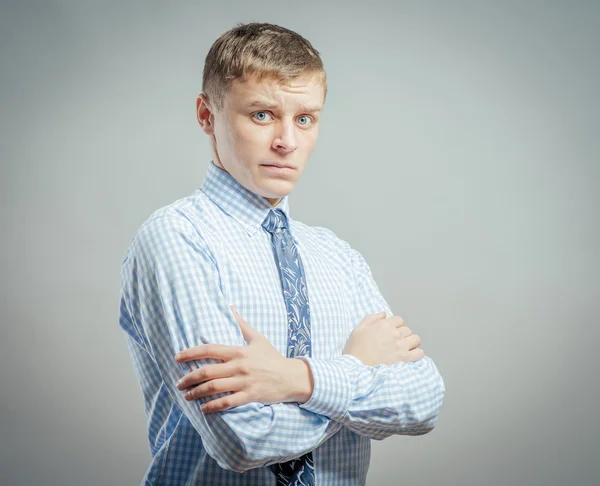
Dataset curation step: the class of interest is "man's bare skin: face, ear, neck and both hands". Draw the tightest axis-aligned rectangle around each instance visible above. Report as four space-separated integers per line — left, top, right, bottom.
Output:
175 76 424 413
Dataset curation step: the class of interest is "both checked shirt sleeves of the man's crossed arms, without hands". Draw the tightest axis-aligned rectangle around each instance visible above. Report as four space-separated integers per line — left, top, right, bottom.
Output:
121 213 445 472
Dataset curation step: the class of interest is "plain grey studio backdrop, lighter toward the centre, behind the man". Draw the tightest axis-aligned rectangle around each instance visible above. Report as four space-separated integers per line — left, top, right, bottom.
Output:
0 0 600 486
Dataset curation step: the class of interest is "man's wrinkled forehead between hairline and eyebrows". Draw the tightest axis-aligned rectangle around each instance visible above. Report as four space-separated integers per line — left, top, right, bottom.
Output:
226 75 325 109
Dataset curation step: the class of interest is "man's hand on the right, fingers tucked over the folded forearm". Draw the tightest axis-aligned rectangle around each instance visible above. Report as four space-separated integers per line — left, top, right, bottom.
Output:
344 312 425 366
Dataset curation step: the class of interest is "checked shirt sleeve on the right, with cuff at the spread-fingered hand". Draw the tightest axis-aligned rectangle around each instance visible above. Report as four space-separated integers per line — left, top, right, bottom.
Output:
300 244 446 440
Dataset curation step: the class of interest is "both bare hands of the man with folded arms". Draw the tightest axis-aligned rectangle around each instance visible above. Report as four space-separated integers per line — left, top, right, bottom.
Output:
175 306 425 413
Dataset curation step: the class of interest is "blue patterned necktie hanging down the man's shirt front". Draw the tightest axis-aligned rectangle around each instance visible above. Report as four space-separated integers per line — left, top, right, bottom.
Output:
262 209 315 486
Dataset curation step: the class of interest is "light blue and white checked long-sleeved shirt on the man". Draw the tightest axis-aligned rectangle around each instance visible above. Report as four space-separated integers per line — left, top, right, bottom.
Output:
119 161 445 486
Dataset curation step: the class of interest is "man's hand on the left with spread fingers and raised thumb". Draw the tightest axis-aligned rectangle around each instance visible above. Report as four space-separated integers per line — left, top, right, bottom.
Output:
175 306 313 413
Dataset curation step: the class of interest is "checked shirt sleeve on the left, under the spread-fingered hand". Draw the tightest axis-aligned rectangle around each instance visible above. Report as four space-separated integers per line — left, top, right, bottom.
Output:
121 213 350 472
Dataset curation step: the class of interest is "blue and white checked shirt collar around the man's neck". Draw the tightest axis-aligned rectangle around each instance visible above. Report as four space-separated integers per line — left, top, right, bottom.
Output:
200 160 290 236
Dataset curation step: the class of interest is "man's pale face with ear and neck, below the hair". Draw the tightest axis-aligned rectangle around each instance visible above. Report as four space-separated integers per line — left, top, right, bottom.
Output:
196 73 325 206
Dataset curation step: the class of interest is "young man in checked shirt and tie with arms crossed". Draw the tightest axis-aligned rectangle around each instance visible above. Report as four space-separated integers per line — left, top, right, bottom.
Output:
120 24 445 486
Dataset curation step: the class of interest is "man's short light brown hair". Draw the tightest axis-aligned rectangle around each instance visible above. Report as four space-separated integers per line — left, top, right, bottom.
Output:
202 22 327 109
